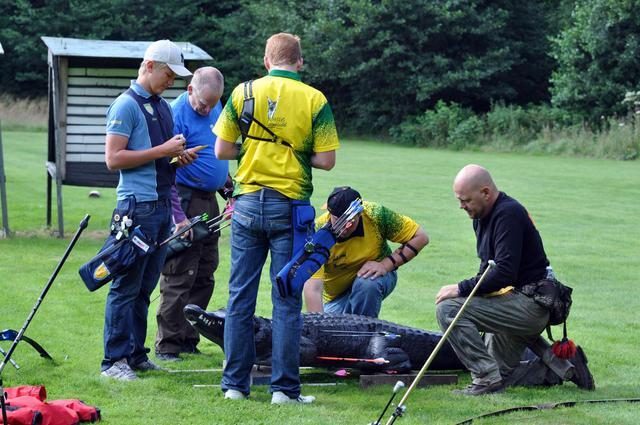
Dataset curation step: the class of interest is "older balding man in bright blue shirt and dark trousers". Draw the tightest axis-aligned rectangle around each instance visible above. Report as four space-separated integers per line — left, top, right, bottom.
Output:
156 66 229 361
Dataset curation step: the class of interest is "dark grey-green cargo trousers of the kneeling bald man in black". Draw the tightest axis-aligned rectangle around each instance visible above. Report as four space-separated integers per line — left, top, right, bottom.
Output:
436 291 573 386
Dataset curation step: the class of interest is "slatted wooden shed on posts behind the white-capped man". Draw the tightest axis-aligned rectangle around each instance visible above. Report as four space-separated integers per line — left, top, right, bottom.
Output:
42 37 212 236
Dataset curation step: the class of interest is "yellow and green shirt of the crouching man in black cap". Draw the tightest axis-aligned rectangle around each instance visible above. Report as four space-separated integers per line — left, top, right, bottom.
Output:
313 201 420 303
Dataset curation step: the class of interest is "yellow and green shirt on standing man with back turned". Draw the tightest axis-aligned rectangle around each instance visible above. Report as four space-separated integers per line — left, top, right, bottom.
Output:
213 70 340 200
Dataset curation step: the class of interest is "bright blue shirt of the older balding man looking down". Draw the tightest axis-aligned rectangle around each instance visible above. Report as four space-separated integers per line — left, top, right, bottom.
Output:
171 92 229 192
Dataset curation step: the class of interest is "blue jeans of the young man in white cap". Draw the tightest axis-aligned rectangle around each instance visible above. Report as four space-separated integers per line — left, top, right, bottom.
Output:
102 200 171 370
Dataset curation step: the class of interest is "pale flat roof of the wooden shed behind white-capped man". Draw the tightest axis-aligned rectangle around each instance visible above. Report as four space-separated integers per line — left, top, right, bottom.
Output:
41 37 212 60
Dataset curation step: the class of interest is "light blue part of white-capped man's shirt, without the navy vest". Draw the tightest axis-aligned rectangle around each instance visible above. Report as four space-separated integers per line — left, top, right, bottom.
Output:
106 80 173 202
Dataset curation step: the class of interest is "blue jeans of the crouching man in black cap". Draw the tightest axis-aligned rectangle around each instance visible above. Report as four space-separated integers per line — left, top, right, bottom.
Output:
324 270 398 317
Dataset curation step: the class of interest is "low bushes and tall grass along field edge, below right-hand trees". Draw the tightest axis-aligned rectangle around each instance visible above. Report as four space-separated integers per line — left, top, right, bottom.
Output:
391 97 640 160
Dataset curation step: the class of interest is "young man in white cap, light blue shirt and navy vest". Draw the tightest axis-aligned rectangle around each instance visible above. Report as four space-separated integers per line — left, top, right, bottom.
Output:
101 40 197 381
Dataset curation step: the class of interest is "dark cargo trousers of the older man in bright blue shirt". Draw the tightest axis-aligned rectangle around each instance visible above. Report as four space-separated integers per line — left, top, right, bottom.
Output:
156 185 220 354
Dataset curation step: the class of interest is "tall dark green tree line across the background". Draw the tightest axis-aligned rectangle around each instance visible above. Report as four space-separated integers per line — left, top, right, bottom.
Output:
0 0 640 135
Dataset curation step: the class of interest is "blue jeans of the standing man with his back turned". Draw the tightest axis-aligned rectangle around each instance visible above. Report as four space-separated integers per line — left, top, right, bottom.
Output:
221 189 302 397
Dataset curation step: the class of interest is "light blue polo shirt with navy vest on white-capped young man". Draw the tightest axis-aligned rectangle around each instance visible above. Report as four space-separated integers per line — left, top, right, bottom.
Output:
106 80 174 202
